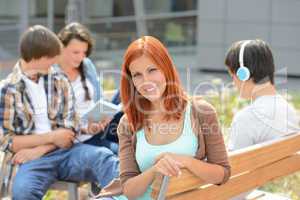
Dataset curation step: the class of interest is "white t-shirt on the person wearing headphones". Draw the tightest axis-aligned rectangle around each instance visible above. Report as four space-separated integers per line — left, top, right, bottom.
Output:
228 95 299 151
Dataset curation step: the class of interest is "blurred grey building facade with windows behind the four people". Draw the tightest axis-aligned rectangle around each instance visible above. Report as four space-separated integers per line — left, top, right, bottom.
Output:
0 0 300 76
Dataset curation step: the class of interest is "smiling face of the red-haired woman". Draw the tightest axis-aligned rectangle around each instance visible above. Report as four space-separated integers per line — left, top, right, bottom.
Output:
129 56 166 102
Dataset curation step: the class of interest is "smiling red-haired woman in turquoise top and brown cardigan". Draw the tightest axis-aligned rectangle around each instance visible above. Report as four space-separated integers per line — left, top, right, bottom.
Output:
98 36 230 199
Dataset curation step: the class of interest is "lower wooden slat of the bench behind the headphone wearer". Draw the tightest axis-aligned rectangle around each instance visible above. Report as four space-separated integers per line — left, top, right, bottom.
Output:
167 154 300 200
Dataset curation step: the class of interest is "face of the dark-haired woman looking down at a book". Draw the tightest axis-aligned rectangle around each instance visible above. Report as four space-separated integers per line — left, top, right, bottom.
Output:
62 39 88 68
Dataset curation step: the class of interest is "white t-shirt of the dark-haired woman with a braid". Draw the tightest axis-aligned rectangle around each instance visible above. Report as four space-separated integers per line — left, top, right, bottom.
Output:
71 76 95 143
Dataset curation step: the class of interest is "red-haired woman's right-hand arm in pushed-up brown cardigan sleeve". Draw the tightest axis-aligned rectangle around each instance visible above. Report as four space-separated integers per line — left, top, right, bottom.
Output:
191 99 230 184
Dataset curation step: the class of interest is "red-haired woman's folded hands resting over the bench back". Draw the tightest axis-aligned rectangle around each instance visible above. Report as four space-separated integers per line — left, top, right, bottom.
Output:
153 153 185 176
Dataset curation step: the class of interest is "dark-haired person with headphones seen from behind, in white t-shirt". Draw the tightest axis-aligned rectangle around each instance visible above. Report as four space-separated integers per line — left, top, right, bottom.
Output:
225 39 299 150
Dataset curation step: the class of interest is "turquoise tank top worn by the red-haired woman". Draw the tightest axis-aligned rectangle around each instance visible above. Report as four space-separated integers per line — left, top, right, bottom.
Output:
113 104 198 200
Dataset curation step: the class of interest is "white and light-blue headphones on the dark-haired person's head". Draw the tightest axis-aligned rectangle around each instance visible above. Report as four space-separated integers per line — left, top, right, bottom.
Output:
236 40 251 81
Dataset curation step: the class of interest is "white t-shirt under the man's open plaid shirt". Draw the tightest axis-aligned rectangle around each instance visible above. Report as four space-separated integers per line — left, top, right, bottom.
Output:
23 76 51 134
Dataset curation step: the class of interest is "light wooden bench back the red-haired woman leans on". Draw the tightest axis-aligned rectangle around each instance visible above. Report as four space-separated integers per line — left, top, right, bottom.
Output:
152 133 300 200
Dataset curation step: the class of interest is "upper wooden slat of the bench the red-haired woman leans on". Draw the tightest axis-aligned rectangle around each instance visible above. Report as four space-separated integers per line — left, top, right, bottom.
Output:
152 133 300 199
